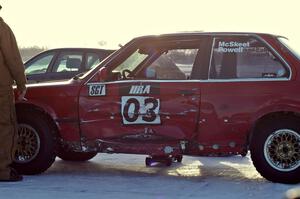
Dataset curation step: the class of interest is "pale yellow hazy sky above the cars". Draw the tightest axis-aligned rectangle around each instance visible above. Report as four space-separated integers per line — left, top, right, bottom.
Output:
0 0 300 48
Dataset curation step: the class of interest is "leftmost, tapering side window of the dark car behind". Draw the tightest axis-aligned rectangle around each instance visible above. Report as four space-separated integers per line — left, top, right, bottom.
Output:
25 52 54 75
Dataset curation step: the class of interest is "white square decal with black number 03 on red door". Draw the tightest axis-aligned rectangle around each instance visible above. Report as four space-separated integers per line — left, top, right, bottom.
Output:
121 96 160 124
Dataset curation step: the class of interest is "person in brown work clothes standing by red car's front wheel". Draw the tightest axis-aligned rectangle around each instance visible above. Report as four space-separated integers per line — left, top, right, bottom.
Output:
0 5 26 181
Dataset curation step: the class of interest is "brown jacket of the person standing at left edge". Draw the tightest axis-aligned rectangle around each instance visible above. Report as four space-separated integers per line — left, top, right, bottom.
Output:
0 17 26 91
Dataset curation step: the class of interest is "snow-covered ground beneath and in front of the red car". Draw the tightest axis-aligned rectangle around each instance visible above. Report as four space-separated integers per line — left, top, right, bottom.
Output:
0 154 299 199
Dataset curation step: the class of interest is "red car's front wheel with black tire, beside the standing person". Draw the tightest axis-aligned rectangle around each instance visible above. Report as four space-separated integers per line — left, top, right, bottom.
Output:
12 112 56 175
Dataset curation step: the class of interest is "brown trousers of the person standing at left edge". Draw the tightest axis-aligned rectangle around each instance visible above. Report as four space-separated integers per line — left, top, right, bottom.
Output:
0 89 16 179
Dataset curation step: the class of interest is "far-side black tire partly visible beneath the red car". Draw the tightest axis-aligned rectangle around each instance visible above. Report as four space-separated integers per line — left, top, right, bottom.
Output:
57 150 97 162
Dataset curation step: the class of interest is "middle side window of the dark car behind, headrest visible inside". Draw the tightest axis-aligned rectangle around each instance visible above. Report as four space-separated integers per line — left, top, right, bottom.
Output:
52 52 83 73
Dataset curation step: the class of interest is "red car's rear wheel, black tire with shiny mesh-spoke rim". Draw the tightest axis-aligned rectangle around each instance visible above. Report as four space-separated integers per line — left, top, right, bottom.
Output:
250 117 300 184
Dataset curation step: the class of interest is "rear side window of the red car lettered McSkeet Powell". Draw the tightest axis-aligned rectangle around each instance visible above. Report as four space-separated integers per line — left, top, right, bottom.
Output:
209 37 289 79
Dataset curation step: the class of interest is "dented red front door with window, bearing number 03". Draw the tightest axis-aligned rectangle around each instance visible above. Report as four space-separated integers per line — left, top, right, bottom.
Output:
79 39 209 141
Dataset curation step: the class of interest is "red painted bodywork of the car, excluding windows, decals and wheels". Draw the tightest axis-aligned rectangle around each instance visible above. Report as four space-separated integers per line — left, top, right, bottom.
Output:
15 33 300 155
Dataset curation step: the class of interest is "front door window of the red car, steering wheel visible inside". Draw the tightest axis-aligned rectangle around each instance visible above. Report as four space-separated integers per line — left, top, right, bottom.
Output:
108 39 203 81
